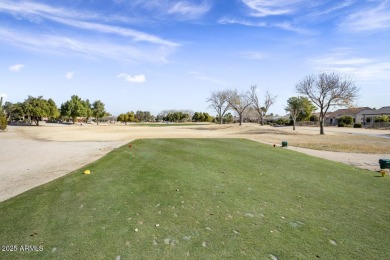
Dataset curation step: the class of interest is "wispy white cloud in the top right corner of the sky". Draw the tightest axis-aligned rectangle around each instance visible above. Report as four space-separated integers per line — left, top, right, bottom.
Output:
340 0 390 32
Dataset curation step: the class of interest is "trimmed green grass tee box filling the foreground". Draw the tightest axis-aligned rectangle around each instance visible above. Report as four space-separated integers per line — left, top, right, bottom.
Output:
0 139 390 259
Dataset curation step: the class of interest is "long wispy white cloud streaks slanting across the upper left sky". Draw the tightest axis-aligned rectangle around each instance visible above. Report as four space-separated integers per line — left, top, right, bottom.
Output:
0 1 180 62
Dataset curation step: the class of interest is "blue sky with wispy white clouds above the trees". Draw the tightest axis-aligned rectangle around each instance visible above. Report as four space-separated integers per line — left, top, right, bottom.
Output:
0 0 390 115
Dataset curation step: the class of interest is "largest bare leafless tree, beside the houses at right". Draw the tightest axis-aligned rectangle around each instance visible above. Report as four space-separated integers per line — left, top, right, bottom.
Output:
295 72 359 135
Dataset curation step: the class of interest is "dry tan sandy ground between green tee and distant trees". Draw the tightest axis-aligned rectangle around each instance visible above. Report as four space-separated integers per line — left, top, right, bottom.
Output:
0 124 390 201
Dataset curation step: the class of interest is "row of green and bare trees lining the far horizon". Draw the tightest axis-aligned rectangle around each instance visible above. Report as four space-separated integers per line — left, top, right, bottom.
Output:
0 73 358 134
